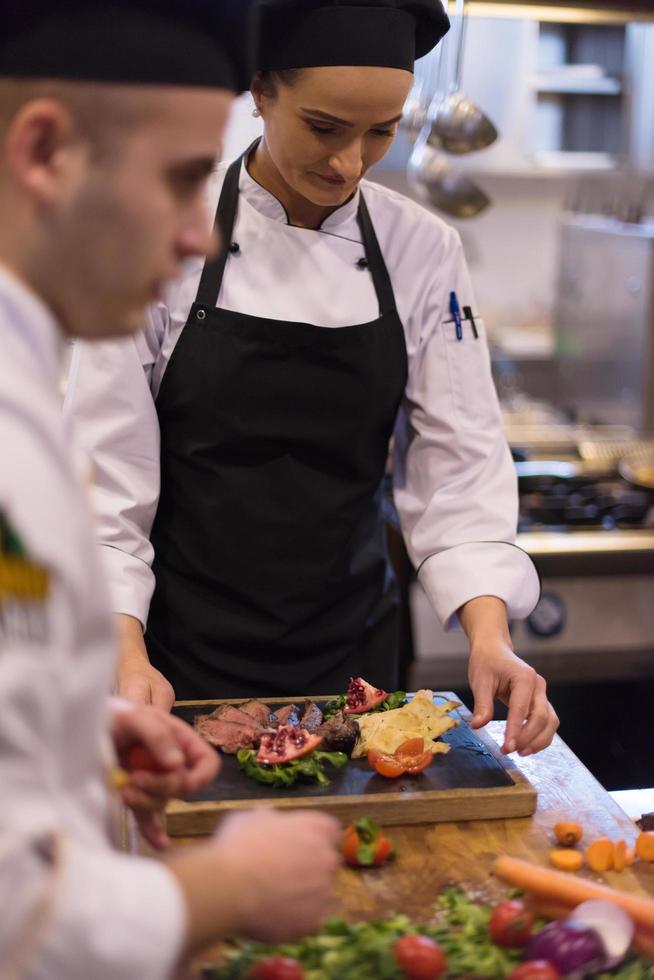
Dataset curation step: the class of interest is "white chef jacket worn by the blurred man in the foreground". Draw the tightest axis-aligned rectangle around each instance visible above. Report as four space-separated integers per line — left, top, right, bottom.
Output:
0 268 185 980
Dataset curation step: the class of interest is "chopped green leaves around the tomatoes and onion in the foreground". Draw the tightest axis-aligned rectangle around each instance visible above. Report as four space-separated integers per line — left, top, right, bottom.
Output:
207 888 654 980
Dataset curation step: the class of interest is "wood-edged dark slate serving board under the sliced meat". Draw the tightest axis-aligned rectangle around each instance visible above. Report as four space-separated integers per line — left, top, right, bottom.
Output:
166 692 536 837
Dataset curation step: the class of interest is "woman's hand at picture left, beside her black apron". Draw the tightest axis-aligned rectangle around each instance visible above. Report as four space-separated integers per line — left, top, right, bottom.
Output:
116 613 175 711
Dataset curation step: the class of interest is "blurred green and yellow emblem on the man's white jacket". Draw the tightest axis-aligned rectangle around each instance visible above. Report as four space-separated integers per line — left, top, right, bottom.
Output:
0 512 49 642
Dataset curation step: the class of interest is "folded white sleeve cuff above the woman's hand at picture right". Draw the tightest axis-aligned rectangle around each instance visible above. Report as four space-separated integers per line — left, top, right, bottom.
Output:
418 541 540 629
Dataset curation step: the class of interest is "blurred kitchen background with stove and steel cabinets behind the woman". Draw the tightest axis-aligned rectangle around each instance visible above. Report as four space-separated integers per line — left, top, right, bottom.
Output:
225 0 654 789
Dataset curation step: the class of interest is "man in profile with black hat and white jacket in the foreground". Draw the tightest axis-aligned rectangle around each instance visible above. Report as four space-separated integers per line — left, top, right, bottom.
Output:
0 0 337 980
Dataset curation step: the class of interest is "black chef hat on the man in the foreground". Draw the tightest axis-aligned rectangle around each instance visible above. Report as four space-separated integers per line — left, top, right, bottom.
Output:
0 0 253 92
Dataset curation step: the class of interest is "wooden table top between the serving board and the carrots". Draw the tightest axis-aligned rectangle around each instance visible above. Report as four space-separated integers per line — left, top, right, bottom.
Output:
169 722 654 962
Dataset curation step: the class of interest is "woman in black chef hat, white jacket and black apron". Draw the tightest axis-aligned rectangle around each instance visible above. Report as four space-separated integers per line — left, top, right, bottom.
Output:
70 0 558 754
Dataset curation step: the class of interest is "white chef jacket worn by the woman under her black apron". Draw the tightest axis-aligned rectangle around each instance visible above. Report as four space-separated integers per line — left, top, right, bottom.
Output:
66 153 539 625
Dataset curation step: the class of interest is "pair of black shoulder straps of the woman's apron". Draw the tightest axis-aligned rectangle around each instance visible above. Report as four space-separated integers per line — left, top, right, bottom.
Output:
195 144 396 316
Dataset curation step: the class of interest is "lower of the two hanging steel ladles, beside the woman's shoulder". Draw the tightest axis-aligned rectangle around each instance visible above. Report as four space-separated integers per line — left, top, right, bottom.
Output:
407 126 490 218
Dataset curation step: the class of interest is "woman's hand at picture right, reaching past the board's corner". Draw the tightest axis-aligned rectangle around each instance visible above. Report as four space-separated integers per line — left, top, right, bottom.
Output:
459 596 559 756
